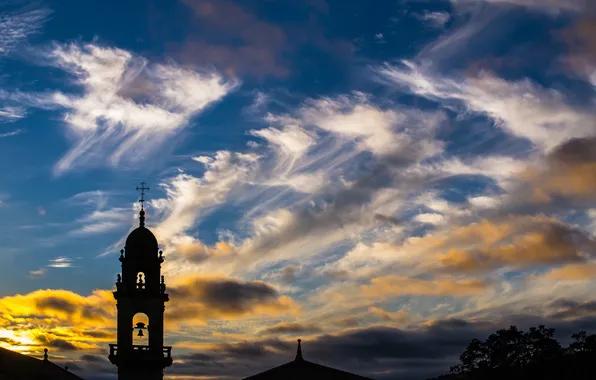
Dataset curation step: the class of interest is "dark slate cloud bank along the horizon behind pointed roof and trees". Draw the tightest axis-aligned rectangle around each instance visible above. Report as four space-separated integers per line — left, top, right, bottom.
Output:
161 314 596 380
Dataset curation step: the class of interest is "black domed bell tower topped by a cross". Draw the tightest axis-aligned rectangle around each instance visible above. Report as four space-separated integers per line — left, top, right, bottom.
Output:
108 182 172 380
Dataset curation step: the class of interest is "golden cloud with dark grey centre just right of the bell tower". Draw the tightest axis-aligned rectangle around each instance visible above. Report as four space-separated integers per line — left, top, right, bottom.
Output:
168 275 298 322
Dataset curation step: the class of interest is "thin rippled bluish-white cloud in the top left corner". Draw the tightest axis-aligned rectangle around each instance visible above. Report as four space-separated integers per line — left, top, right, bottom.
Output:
0 4 52 56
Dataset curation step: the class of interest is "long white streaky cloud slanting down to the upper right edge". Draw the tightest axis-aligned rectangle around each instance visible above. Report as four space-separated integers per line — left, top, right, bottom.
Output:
379 61 596 151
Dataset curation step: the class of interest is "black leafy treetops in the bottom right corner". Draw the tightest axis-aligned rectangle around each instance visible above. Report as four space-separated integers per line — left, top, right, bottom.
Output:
428 325 596 380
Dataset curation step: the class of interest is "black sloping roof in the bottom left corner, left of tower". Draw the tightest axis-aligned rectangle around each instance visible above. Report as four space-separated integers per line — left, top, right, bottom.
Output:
0 347 83 380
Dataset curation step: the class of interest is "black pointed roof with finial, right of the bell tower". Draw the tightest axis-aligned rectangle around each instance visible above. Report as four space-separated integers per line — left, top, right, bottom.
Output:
244 339 372 380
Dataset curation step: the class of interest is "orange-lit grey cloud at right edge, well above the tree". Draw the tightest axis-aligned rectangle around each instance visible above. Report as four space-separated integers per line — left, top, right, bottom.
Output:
418 216 595 272
